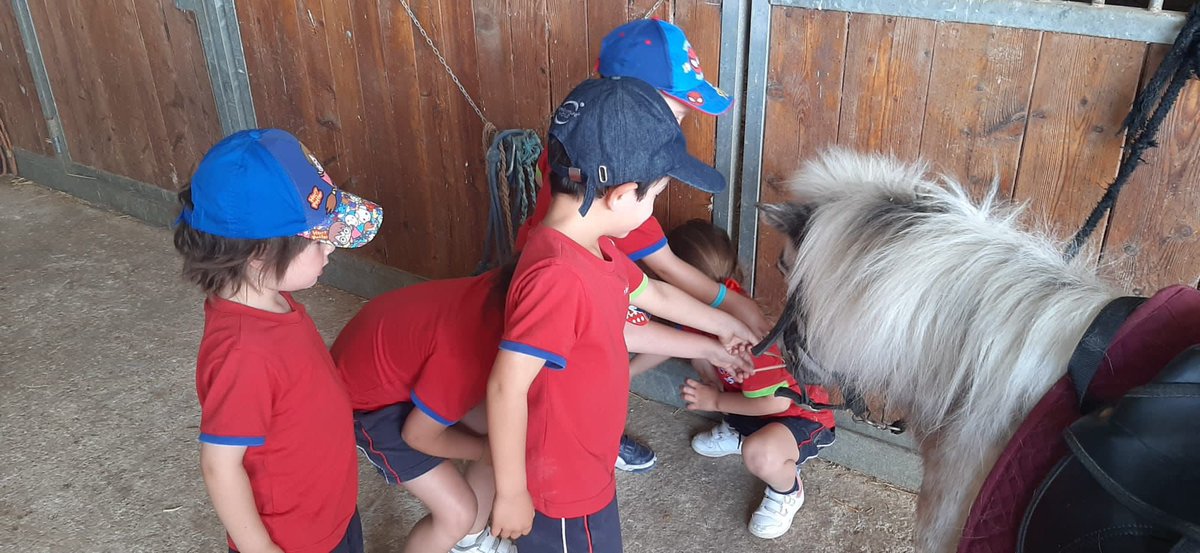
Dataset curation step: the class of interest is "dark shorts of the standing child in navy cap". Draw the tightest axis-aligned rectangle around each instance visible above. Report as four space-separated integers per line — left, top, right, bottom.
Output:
516 498 623 553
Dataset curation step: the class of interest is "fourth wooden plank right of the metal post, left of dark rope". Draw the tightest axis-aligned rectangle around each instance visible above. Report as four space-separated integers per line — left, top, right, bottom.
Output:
1015 34 1146 238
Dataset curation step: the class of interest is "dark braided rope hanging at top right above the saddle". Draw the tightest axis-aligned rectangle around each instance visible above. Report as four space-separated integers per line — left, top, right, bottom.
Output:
1066 4 1200 259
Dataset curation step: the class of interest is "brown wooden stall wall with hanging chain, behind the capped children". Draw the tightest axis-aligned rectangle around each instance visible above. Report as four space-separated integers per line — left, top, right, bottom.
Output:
238 0 720 278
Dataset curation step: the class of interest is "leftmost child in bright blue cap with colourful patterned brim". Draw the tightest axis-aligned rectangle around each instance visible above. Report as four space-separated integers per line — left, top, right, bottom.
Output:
175 130 383 553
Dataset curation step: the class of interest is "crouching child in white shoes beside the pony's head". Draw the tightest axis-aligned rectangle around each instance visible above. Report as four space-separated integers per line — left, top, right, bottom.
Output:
634 220 834 539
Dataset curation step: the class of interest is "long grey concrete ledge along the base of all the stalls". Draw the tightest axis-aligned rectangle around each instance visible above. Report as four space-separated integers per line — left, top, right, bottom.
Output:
16 149 920 489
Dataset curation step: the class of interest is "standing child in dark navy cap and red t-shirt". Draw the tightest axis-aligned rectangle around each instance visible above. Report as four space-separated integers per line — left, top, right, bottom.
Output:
487 78 754 553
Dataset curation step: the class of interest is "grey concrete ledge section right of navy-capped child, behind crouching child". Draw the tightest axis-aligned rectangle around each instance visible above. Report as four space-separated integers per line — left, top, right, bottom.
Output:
631 360 920 491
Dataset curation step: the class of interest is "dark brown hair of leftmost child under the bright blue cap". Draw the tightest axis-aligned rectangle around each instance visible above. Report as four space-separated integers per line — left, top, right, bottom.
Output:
175 187 312 294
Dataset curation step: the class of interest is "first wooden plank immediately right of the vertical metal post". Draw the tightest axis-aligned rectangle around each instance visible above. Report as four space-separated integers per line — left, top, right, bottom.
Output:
743 7 862 317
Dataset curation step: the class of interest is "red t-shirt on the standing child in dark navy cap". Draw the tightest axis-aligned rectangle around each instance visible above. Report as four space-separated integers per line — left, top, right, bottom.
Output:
500 227 648 518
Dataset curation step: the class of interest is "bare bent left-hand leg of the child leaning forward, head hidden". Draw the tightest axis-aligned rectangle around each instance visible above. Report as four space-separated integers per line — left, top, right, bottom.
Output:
403 463 478 553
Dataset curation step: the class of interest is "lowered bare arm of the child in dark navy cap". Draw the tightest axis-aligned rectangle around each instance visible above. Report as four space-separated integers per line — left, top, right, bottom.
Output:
487 349 546 540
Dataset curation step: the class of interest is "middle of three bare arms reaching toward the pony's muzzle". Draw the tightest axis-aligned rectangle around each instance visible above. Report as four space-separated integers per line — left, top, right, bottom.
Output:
631 277 762 349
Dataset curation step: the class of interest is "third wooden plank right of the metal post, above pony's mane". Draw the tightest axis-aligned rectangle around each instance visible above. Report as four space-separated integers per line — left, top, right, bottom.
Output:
920 23 1042 198
